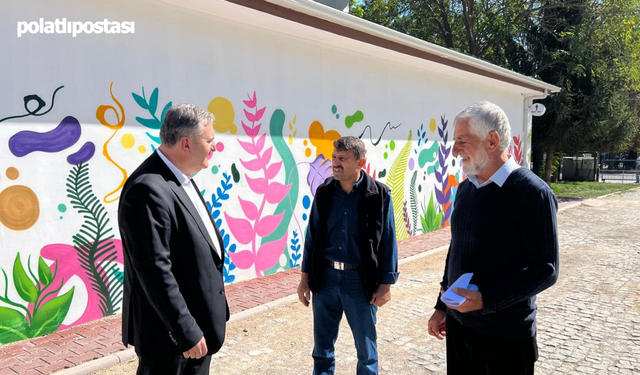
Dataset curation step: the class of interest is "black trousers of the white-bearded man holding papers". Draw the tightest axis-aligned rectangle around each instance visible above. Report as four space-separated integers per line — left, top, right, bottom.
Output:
446 315 538 375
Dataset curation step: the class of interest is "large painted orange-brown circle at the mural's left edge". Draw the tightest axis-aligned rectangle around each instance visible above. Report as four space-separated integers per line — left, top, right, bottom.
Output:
0 185 40 230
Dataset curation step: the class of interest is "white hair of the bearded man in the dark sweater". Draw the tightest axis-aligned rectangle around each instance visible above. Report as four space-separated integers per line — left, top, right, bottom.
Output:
453 101 511 151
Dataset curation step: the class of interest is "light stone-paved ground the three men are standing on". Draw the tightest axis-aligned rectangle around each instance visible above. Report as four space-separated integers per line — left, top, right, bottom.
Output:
91 190 640 375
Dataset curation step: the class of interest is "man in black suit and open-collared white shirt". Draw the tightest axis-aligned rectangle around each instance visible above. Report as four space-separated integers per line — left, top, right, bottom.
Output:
118 104 229 375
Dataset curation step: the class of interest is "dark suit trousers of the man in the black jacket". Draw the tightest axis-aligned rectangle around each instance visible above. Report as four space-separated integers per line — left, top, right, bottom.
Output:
136 354 211 375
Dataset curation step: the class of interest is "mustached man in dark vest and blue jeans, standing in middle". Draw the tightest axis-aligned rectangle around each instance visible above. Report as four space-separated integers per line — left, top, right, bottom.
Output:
298 137 398 375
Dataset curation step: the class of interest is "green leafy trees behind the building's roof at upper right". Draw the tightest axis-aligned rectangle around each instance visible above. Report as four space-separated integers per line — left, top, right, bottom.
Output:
352 0 640 179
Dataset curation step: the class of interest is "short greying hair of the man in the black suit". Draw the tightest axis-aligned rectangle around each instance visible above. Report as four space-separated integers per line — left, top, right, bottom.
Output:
160 104 213 147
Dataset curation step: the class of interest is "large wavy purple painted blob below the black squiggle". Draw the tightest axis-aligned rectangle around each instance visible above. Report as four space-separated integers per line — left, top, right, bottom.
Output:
9 116 82 157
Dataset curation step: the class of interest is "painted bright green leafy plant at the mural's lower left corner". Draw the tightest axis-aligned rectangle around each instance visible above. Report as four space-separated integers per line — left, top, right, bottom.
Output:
0 254 75 344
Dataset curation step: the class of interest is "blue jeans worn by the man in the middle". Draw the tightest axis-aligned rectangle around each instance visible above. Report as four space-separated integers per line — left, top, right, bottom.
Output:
312 267 378 375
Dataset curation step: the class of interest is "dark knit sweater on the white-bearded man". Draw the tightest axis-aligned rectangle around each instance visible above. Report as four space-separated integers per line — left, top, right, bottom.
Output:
436 168 558 338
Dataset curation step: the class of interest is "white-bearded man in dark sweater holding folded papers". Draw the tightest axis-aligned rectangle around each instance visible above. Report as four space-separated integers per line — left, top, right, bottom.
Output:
429 102 558 375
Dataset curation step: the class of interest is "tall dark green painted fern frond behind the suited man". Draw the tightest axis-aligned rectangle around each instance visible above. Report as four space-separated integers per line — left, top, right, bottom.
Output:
66 163 122 316
